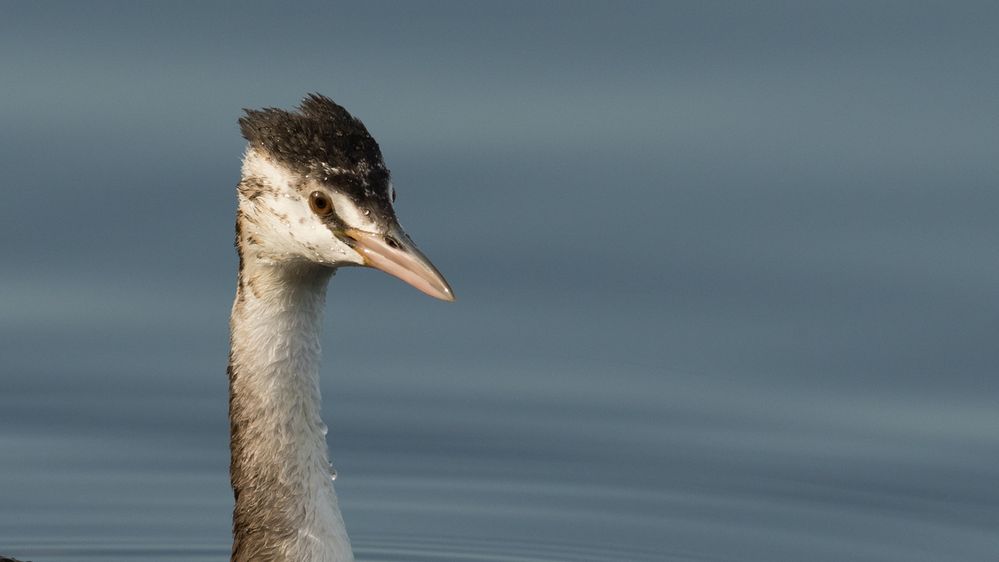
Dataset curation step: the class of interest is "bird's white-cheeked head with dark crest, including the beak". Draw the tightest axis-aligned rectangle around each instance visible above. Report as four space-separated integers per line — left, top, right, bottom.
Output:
238 94 454 301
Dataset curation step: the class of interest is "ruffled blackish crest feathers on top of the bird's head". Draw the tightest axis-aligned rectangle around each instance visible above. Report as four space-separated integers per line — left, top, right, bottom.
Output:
239 94 389 192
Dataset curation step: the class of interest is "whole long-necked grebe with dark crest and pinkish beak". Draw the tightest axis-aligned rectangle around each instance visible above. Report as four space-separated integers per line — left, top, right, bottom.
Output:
227 94 455 562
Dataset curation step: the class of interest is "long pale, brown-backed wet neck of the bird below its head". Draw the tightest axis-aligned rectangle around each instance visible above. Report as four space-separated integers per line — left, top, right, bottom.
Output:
229 250 353 562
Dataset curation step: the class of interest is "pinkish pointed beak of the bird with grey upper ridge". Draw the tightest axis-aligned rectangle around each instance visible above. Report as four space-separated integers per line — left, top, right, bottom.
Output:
343 223 455 302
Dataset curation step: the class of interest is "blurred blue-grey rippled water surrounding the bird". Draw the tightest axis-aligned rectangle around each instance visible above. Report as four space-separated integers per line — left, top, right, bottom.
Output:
0 1 999 562
